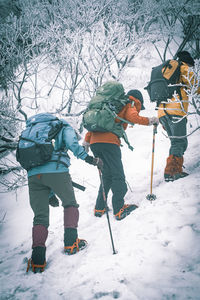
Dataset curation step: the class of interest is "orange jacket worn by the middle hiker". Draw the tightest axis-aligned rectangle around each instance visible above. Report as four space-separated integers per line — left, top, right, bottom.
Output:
85 96 149 146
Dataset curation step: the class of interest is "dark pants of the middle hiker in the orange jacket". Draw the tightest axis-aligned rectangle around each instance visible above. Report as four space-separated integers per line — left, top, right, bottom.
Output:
91 143 127 214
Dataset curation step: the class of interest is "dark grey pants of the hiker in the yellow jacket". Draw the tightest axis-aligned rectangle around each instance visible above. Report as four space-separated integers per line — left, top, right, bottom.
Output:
160 115 188 157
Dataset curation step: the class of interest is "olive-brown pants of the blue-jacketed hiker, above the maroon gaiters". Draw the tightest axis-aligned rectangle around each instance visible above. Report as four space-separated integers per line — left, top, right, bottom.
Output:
28 172 79 228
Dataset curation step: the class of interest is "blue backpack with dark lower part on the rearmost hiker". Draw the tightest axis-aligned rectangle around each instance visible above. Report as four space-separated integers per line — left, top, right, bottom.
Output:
16 113 63 171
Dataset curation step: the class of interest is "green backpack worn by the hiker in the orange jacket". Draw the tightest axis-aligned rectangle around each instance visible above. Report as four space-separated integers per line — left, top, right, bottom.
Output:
82 81 133 150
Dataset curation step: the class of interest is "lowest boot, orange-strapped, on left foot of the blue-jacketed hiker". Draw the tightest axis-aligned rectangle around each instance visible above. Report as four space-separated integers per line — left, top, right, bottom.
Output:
26 246 46 273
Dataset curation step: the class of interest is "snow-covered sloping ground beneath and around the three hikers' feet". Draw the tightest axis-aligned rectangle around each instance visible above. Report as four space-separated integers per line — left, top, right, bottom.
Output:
0 97 200 300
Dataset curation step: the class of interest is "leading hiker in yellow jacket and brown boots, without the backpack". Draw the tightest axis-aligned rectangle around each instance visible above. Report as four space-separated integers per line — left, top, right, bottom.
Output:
158 51 200 182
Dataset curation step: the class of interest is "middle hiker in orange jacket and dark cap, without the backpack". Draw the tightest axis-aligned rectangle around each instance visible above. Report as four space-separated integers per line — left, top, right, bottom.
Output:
83 88 159 220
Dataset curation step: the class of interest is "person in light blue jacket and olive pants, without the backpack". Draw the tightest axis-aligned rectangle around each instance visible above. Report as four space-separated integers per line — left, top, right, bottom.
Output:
24 114 102 271
